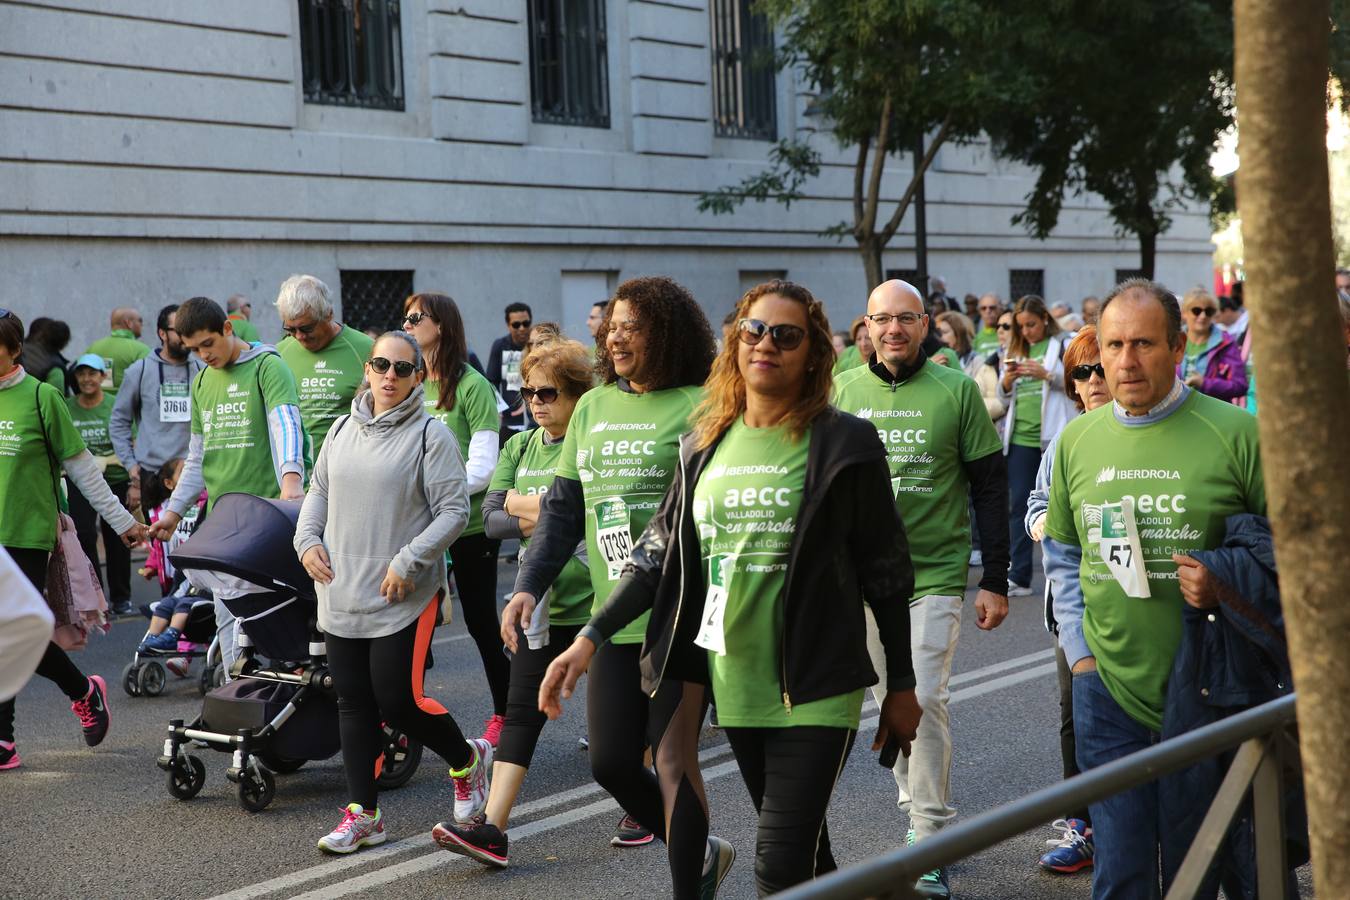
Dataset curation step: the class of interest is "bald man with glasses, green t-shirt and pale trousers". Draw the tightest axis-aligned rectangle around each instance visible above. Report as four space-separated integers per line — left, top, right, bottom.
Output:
834 281 1008 897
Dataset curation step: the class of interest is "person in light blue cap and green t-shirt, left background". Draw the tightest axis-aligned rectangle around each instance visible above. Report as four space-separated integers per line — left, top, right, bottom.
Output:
66 354 131 615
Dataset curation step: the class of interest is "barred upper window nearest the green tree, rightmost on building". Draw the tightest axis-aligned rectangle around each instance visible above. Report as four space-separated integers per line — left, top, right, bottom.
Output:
709 0 778 140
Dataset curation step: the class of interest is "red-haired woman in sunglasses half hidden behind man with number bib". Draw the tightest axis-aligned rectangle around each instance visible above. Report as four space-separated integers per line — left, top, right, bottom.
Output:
1025 325 1111 874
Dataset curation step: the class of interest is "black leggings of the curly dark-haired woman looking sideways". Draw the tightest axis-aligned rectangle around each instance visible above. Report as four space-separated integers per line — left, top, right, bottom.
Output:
586 644 709 900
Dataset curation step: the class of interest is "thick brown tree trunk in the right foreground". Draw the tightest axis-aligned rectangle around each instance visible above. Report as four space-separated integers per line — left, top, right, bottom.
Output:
1234 0 1350 897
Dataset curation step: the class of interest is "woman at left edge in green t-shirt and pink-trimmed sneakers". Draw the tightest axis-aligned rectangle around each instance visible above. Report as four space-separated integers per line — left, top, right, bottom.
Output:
0 309 146 770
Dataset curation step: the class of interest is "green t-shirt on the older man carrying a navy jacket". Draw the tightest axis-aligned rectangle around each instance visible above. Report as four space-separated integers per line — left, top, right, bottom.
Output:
1045 391 1265 731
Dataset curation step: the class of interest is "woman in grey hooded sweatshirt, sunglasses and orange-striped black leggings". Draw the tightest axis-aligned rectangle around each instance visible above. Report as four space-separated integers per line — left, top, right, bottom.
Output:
296 332 491 853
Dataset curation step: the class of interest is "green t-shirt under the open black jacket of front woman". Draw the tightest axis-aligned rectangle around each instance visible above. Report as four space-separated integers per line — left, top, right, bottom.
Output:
694 418 863 729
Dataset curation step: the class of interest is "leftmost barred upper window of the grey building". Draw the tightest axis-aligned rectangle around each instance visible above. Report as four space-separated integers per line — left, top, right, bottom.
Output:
300 0 404 111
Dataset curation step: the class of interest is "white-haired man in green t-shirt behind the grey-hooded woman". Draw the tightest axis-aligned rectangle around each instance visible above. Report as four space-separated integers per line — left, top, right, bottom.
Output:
277 275 375 457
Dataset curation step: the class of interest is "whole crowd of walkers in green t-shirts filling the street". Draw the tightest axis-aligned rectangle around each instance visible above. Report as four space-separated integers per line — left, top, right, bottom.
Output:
0 273 1350 897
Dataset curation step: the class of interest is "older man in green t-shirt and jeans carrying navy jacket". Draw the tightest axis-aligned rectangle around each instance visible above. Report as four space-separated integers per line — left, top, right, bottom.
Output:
1042 279 1265 896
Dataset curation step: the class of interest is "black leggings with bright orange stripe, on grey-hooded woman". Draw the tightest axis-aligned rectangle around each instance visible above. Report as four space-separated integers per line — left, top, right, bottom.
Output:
325 595 474 810
